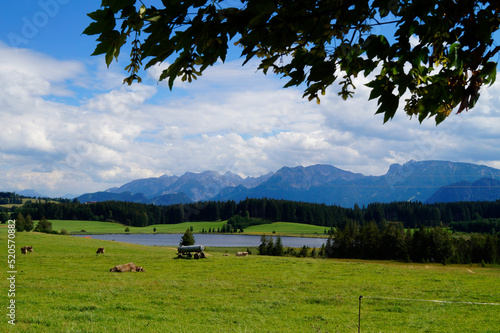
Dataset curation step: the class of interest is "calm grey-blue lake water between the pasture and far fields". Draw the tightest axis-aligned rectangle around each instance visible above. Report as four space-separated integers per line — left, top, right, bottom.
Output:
74 234 326 248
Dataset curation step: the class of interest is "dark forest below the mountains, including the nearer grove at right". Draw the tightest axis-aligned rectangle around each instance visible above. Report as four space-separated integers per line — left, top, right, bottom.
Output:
0 194 500 263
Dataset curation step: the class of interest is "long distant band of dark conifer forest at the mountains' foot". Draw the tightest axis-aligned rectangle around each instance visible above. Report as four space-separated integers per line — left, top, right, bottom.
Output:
0 193 500 233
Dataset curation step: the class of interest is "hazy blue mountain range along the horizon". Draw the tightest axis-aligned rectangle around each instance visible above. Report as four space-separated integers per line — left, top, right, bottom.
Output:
78 160 500 207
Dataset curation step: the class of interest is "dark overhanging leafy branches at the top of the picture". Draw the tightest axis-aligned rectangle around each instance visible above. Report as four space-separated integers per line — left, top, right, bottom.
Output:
84 0 500 123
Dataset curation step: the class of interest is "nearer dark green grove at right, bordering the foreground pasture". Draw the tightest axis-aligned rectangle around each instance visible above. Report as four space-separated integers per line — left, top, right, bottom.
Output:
325 221 500 264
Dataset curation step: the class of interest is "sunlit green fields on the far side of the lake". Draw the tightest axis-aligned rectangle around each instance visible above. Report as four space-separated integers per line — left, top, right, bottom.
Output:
47 220 326 237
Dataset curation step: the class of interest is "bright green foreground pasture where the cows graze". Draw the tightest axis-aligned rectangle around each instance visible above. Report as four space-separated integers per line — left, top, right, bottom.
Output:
0 225 500 333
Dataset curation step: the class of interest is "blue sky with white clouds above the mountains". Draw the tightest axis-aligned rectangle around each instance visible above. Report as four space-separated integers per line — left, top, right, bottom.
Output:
0 0 500 196
